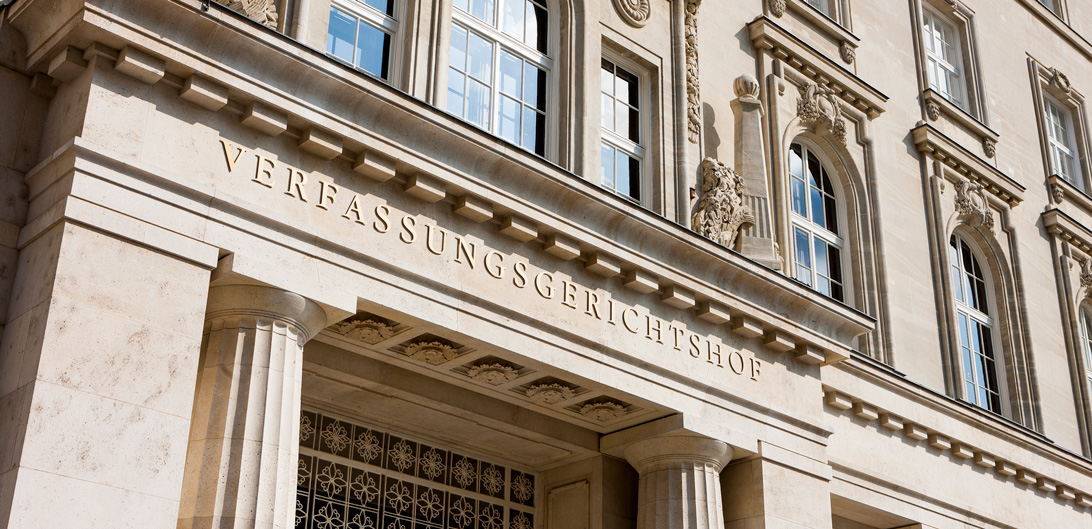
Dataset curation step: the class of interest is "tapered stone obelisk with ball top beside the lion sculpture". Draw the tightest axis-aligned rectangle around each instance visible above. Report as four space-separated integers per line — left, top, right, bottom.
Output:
732 75 781 270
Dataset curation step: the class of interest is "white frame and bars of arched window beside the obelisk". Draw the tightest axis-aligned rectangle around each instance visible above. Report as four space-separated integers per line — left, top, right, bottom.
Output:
786 137 853 303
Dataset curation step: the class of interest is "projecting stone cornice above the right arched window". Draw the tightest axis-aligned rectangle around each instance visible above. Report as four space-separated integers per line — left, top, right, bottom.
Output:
911 122 1025 208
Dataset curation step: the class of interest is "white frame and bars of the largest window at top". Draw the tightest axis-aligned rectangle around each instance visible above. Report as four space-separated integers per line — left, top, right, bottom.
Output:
432 0 562 160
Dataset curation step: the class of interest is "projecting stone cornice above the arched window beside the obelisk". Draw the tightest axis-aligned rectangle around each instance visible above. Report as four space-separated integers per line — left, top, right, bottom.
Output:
747 16 888 119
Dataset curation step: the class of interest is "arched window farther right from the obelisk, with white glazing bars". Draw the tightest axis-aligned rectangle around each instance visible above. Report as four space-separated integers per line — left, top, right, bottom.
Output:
948 235 1001 413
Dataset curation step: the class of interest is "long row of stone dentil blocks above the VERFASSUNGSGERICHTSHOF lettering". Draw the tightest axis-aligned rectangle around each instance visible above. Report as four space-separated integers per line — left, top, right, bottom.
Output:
42 43 869 365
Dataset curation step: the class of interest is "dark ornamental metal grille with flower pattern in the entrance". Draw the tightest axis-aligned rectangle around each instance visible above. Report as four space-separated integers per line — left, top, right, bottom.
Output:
296 410 535 529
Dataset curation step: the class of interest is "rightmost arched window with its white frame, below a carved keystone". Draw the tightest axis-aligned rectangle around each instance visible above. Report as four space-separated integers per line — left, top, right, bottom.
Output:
948 233 1010 415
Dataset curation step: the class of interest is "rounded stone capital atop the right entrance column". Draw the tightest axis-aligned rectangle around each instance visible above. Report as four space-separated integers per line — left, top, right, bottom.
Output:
625 433 733 475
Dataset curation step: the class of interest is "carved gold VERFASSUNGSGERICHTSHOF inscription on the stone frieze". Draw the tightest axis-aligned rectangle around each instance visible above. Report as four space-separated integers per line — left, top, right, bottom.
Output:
219 139 762 380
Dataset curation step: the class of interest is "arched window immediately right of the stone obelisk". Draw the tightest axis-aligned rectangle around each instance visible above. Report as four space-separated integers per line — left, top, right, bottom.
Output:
788 143 845 302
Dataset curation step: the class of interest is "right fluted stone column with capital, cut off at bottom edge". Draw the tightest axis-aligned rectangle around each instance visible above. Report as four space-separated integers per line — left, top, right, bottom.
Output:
626 434 732 529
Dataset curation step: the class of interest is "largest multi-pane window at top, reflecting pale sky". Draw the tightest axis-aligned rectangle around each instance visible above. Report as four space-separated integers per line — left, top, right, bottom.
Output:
447 0 553 155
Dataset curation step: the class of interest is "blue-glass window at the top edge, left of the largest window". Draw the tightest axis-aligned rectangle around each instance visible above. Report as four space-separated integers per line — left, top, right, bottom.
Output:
327 0 399 80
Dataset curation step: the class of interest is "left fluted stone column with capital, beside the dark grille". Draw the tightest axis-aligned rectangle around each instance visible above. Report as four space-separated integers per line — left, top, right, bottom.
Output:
178 285 325 529
